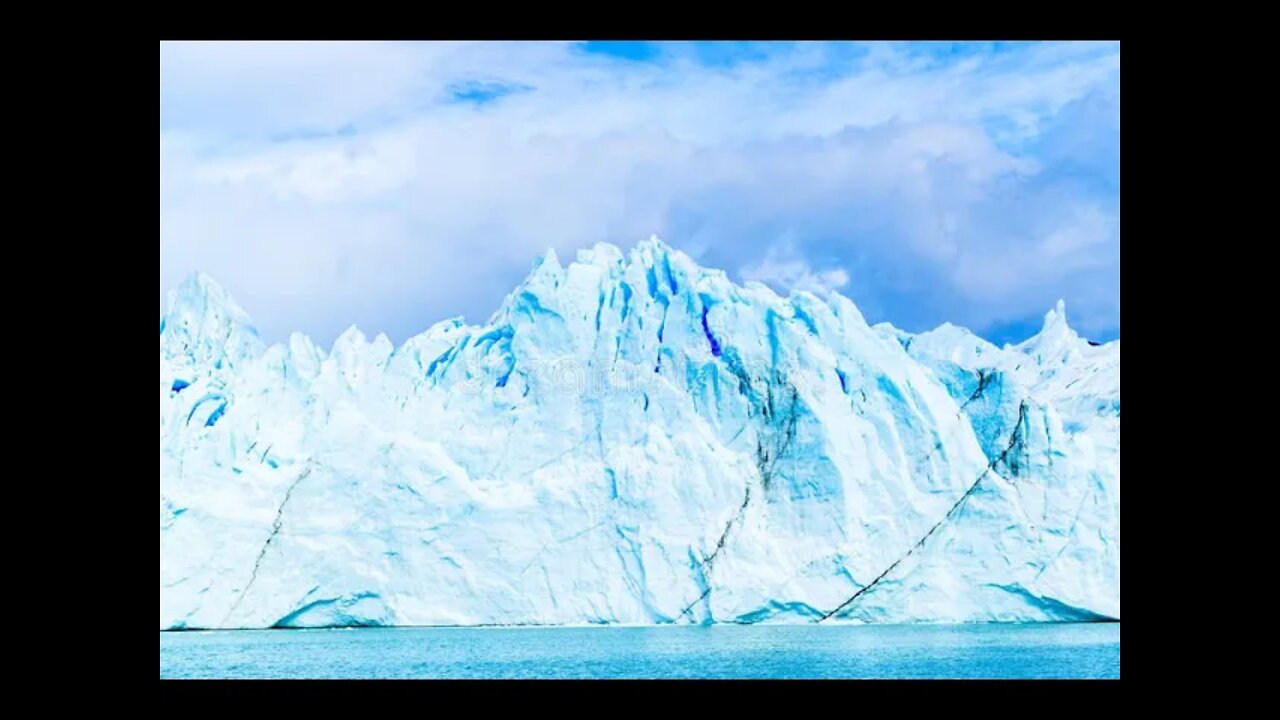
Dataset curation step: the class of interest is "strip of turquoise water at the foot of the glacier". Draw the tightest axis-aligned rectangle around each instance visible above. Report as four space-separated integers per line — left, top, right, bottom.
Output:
160 623 1120 678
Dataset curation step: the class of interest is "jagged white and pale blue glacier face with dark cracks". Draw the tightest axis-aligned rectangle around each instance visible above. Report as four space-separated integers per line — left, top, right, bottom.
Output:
160 238 1120 629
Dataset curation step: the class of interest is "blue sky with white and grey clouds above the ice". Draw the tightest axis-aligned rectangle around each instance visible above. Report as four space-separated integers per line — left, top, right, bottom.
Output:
160 41 1120 345
